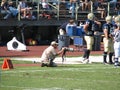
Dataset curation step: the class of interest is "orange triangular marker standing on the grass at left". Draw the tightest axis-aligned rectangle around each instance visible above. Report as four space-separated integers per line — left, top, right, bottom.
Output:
2 58 13 70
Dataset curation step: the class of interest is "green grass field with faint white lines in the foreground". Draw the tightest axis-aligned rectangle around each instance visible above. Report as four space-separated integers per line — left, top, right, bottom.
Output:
0 61 120 90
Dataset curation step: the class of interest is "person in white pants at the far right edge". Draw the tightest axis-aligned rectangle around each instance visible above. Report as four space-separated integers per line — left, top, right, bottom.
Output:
112 16 120 67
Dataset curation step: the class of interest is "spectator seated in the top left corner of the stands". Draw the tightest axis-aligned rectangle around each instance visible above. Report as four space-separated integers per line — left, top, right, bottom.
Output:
1 0 11 19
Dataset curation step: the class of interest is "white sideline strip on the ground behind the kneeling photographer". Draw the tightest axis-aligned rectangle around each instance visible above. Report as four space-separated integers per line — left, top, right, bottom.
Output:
7 56 103 64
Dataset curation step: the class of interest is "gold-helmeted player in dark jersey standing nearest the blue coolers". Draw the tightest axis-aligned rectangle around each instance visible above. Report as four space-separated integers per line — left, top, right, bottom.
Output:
83 13 101 63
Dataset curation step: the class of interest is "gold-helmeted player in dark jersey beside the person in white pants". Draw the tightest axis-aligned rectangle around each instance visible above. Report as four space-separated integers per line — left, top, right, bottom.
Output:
103 16 114 65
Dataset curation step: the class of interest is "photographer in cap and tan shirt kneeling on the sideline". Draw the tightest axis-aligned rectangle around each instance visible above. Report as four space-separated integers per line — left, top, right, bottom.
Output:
41 41 65 67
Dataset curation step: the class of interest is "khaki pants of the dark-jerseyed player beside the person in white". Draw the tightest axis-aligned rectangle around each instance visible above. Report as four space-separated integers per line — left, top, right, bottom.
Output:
103 37 114 52
